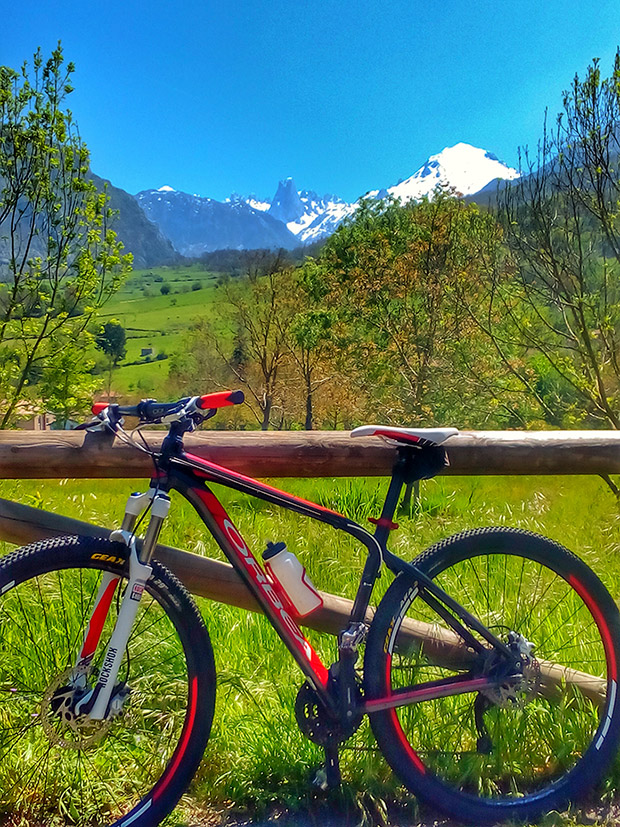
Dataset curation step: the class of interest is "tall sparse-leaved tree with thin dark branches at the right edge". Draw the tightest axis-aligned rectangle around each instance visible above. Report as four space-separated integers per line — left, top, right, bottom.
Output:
487 53 620 429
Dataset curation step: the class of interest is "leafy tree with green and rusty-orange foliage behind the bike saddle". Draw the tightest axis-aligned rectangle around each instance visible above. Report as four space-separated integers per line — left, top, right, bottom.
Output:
304 193 499 423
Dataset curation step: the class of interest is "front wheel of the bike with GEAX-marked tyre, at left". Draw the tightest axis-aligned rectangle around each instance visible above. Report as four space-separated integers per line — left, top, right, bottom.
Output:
0 537 215 827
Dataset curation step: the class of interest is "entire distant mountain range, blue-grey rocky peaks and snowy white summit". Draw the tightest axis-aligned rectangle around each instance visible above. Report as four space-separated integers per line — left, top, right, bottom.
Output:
101 143 518 267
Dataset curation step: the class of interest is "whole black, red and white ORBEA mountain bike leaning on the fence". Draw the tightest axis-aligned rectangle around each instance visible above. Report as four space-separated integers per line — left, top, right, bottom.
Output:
0 391 620 827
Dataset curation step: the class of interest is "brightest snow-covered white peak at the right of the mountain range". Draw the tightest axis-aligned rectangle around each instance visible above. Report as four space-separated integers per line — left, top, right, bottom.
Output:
376 143 519 202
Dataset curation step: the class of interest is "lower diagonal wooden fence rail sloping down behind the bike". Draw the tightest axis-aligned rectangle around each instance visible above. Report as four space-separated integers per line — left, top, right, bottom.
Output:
0 499 605 704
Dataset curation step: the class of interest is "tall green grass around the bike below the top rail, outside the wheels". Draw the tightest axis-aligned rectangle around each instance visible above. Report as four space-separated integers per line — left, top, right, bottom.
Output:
0 468 620 825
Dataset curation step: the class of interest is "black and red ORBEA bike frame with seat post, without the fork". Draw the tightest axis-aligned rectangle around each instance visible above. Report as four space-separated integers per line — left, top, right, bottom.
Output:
151 423 519 718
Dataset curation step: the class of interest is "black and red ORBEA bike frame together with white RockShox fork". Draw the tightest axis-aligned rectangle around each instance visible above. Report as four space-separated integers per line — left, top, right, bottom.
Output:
75 428 520 721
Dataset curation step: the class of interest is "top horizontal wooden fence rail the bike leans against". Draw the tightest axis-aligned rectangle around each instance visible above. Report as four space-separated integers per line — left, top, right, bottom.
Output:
0 431 620 479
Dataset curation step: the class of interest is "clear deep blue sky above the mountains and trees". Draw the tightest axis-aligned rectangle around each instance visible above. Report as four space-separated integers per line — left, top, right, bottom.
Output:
0 0 620 200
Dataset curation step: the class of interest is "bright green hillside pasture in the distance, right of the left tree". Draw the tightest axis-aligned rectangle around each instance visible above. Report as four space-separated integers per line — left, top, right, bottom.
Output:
101 265 226 399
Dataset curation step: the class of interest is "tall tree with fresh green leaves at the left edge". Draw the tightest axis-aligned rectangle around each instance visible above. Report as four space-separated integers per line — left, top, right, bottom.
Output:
0 45 131 428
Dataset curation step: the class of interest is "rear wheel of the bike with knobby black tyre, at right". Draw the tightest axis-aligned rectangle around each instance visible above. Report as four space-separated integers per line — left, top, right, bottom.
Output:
364 529 620 825
